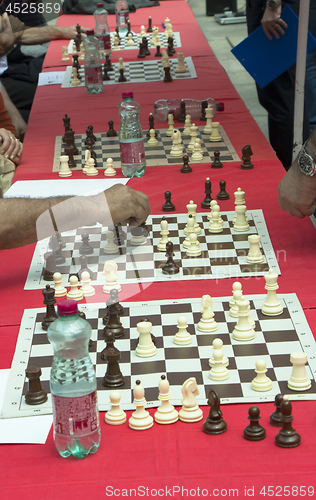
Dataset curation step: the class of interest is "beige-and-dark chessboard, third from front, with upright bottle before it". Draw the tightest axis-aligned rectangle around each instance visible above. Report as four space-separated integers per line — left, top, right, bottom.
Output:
53 126 240 172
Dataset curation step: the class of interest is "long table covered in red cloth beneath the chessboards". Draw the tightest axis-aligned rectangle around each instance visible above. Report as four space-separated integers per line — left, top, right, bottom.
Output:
0 1 316 500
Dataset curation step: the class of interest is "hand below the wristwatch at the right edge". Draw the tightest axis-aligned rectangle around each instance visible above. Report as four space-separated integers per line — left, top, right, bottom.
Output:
278 160 316 219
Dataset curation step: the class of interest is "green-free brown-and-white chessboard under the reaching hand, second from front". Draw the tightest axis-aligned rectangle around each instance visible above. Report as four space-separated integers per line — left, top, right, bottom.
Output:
25 210 280 290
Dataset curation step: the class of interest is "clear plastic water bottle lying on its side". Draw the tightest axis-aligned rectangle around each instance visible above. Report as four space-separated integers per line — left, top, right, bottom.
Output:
154 97 224 121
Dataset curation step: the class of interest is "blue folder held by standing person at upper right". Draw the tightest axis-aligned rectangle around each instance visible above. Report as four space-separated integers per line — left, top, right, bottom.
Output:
231 5 316 88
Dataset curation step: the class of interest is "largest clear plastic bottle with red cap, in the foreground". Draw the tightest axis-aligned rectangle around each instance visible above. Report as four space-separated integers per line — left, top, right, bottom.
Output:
47 300 101 458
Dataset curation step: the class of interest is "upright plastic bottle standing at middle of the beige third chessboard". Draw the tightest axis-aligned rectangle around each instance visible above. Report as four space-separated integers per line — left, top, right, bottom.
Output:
117 92 146 177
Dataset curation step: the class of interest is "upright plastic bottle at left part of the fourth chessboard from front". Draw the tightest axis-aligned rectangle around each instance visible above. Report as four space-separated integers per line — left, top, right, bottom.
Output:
83 30 103 94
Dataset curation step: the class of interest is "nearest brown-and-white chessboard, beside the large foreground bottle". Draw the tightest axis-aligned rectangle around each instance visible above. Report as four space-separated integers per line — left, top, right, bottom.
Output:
1 294 316 418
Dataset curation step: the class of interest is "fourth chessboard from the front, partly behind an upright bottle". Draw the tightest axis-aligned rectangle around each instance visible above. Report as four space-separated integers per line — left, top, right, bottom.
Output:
61 57 197 89
